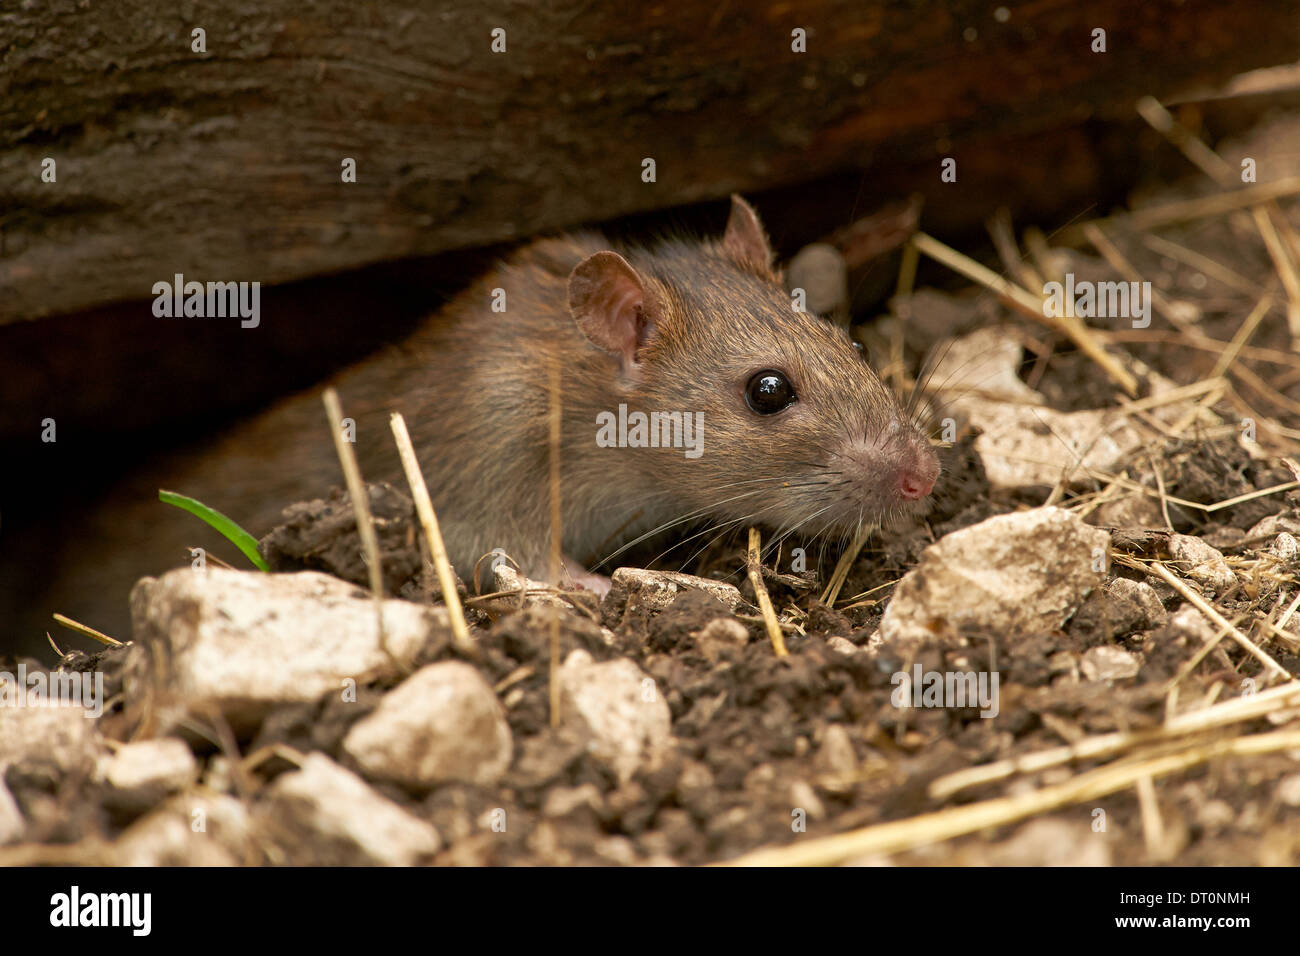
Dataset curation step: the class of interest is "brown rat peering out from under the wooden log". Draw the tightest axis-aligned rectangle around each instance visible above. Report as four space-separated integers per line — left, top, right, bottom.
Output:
22 196 939 639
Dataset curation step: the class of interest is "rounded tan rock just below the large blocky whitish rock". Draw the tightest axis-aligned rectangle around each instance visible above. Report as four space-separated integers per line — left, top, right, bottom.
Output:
343 661 514 790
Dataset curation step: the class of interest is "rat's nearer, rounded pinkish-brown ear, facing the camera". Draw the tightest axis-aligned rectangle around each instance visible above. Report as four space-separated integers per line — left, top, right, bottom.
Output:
569 252 657 369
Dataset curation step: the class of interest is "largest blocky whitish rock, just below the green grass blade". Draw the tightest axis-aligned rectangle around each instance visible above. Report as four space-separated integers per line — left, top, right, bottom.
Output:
127 568 451 732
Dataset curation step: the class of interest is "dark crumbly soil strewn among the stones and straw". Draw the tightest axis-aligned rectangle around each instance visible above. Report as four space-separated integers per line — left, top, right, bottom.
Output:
5 113 1300 865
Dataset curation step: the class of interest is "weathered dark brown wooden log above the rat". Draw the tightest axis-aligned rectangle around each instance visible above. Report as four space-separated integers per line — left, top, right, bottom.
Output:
0 0 1295 321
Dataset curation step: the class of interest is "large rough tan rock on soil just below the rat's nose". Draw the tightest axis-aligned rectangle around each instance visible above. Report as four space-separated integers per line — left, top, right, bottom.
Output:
872 507 1110 643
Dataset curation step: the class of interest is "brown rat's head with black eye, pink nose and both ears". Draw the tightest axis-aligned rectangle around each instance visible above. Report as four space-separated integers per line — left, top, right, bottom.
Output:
569 196 939 533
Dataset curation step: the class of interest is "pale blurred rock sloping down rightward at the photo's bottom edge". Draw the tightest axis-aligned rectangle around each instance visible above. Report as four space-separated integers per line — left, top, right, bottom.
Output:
256 754 442 866
